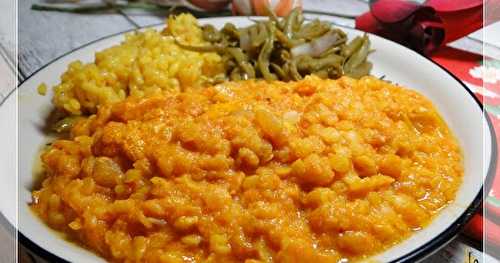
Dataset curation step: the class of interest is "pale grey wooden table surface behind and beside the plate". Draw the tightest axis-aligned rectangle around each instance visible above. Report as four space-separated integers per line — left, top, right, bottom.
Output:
0 0 500 262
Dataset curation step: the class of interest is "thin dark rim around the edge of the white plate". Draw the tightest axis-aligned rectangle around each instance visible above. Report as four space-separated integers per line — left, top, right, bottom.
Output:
5 17 498 263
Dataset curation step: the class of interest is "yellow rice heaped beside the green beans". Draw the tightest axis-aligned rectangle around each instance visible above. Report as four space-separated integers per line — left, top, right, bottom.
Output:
53 14 223 115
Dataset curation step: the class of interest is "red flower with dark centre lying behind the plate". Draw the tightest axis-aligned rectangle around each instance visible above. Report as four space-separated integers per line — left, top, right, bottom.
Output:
356 0 500 55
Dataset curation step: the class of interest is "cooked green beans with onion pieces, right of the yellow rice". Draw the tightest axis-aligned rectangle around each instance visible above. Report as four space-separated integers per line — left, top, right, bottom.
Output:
178 8 372 81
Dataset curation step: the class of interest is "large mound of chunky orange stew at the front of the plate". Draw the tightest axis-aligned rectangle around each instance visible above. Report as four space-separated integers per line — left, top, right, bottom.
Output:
31 76 463 262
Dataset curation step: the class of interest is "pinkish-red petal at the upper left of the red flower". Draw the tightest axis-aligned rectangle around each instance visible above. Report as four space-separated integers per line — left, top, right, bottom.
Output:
370 0 424 23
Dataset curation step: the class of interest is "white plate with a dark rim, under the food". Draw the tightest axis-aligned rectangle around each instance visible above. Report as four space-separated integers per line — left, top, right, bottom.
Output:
0 17 496 262
